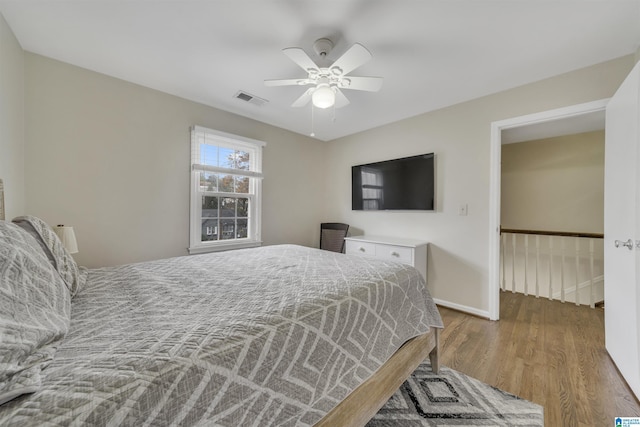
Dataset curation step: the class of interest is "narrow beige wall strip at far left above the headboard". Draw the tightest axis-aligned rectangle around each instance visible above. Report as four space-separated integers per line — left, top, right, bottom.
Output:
0 14 25 219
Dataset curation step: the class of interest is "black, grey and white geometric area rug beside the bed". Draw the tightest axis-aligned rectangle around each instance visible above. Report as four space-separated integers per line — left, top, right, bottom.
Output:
367 362 544 427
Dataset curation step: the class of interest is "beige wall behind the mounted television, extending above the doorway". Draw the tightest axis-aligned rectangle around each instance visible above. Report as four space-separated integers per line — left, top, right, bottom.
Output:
327 55 634 315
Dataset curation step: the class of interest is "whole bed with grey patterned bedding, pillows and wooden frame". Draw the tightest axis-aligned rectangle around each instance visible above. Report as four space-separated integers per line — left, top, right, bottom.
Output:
0 217 442 426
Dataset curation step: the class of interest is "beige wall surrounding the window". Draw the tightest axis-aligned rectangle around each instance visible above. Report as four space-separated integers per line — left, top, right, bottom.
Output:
25 53 325 267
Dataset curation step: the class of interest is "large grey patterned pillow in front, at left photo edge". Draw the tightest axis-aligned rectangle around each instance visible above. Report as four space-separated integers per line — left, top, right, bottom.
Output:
0 221 71 405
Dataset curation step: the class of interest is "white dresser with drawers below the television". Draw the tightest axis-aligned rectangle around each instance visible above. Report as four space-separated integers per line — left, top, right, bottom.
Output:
344 235 428 281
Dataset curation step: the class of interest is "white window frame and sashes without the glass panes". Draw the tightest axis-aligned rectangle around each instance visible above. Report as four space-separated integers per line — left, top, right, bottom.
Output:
189 126 267 254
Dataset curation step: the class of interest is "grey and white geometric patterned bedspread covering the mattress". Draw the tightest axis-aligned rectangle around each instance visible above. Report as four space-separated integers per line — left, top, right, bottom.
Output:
0 245 442 426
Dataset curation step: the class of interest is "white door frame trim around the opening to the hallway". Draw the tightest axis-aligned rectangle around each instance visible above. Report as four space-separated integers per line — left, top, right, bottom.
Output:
488 98 610 320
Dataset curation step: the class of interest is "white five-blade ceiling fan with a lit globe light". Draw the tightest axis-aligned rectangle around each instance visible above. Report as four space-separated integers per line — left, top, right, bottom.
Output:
264 38 383 108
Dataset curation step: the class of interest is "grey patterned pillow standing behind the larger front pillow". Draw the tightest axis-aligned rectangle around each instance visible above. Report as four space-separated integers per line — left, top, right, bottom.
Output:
13 215 80 297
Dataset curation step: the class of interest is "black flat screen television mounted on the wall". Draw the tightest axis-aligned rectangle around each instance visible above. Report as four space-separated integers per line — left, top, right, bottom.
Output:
351 153 435 211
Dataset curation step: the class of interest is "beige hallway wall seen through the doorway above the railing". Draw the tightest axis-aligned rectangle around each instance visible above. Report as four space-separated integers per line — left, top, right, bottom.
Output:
501 131 604 233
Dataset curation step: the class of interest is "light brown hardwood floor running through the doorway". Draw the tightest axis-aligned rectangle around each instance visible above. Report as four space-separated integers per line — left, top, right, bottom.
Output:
439 292 640 427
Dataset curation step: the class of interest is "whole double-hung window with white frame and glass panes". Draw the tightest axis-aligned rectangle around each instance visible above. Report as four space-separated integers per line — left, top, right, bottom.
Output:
189 126 266 254
